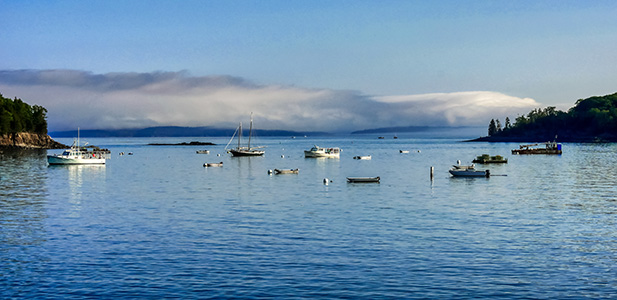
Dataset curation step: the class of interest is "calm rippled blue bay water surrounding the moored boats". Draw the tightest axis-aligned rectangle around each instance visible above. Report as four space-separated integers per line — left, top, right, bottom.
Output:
0 136 617 299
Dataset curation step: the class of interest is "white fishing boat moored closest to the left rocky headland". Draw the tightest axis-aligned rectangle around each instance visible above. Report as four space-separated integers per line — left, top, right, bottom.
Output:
47 128 111 165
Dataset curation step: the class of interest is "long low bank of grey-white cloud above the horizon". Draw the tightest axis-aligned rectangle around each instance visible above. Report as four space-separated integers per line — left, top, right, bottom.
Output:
0 70 540 132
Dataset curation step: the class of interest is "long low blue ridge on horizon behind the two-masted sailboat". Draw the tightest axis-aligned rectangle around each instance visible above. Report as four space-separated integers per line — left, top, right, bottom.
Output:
49 126 328 138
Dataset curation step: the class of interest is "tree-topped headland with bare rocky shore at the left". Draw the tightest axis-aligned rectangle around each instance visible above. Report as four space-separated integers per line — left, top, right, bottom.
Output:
0 94 68 149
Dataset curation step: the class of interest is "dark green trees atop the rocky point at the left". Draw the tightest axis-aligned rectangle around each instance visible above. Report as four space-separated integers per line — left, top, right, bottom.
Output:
0 94 47 135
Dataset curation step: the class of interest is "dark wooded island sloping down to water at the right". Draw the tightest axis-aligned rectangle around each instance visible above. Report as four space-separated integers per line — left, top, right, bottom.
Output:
471 93 617 143
